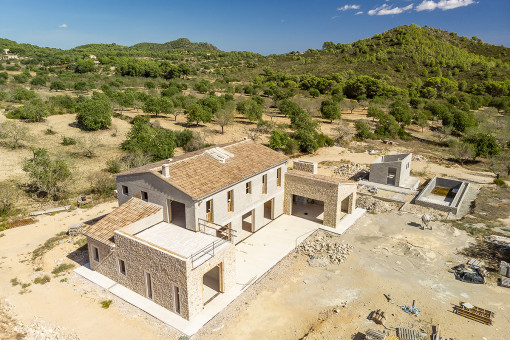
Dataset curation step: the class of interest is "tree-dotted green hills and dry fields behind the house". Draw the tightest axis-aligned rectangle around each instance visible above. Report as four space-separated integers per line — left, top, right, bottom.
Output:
0 25 510 220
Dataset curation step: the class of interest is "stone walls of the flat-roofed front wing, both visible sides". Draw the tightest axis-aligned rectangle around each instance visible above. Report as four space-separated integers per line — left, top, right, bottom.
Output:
88 232 236 320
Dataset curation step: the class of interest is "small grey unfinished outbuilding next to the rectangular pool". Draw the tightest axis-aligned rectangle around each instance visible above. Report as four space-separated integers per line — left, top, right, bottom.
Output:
368 153 413 186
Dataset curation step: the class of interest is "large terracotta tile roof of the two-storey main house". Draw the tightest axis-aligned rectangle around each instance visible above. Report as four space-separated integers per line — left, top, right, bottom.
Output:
118 140 288 200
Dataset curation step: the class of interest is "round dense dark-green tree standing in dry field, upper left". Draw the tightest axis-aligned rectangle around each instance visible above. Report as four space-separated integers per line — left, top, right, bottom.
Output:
76 98 113 131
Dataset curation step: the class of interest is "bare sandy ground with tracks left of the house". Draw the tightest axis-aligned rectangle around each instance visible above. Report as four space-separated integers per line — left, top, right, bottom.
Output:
0 202 179 339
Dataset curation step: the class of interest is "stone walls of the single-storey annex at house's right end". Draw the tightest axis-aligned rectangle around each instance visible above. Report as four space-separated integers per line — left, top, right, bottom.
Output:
284 172 356 228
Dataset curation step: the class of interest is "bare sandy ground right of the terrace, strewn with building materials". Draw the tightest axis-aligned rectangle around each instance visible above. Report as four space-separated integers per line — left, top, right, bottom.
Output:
196 213 510 339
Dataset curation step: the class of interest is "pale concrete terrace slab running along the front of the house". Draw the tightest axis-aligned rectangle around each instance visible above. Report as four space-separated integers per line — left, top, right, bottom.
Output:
74 208 366 336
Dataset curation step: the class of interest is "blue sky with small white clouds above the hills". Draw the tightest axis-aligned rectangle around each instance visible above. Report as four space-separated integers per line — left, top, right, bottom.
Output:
0 0 510 54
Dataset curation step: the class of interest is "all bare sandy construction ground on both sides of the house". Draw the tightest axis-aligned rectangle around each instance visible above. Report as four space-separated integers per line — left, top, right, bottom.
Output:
0 147 510 340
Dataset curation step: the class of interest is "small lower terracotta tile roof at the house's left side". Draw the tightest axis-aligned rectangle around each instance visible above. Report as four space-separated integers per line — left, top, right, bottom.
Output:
83 197 162 246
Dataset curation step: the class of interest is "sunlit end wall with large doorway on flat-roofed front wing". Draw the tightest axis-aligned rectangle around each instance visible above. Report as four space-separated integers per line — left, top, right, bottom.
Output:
187 243 236 319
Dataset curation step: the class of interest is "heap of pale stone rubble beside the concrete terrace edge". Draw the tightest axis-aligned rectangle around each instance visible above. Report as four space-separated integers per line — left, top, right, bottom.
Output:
297 234 352 267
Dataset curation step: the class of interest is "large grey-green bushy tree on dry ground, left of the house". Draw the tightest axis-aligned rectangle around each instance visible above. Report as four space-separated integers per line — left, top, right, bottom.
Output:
23 148 71 199
